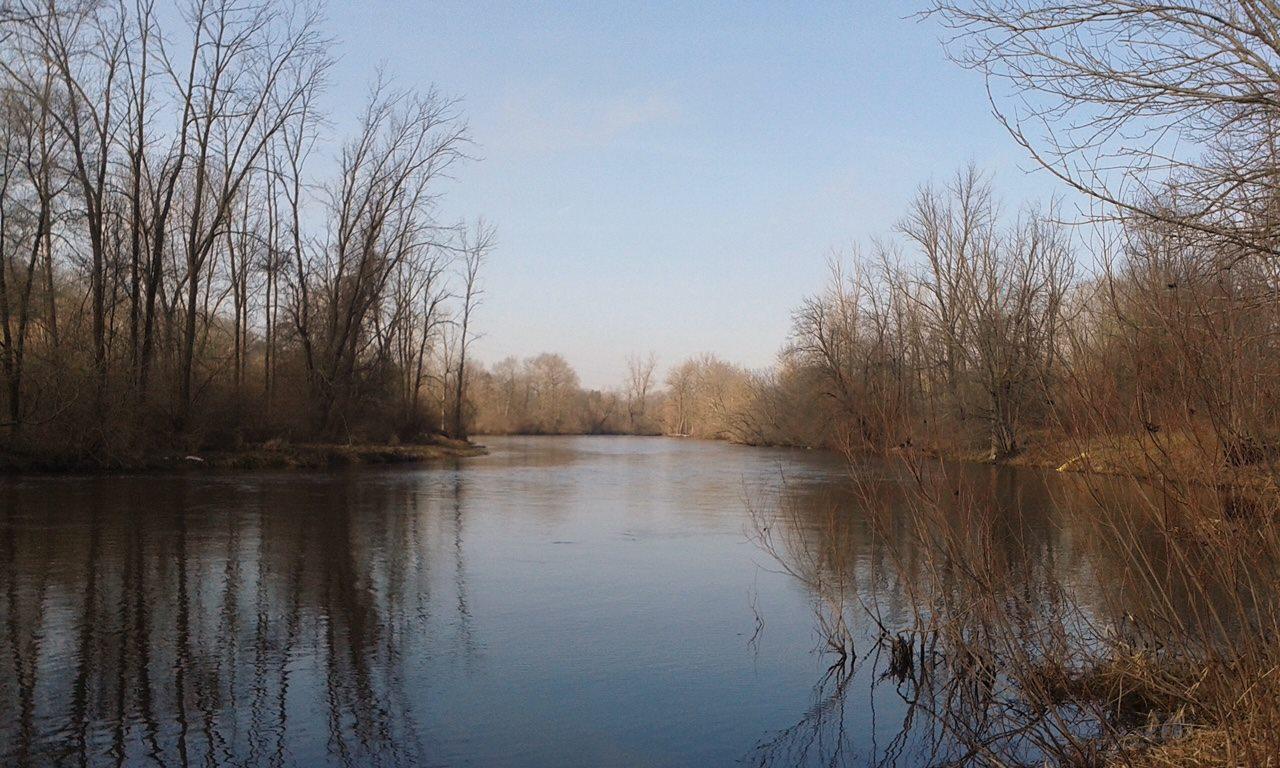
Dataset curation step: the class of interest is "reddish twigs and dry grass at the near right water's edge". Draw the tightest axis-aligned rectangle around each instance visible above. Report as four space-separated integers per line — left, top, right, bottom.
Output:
760 440 1280 768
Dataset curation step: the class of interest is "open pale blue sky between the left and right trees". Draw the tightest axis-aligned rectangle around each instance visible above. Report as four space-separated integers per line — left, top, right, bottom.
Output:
326 0 1057 388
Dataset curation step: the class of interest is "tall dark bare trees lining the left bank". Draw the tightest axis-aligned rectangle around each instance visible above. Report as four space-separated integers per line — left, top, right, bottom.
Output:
0 0 493 465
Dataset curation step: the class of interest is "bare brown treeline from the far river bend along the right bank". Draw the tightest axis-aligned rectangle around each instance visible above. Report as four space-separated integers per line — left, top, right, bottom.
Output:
472 157 1280 472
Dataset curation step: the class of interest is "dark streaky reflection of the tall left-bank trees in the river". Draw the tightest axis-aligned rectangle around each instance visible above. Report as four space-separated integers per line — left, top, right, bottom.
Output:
0 476 475 765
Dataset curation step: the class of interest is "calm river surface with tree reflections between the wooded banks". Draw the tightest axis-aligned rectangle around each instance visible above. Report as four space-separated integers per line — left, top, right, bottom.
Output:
0 438 1239 767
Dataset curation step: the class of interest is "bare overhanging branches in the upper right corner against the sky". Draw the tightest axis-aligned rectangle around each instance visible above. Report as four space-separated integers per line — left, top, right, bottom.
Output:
931 0 1280 257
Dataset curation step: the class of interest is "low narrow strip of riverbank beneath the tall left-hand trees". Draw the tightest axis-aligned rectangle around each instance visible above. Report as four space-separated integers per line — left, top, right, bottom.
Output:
0 436 488 475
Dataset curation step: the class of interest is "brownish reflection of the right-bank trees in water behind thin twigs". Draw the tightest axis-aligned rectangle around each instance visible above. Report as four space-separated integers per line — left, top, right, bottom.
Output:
753 455 1274 765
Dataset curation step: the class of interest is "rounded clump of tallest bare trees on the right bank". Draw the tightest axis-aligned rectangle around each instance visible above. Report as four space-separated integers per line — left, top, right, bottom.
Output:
762 166 1075 460
